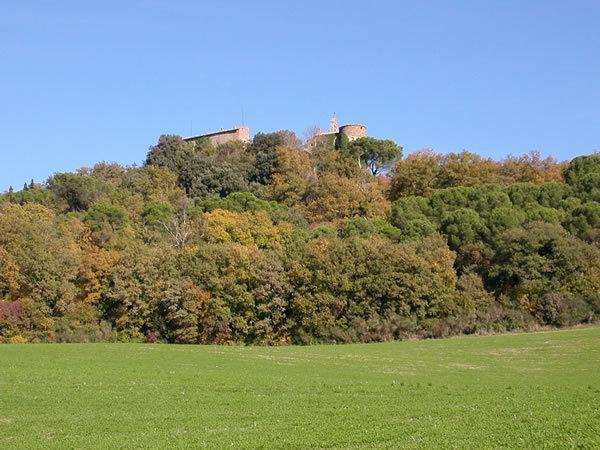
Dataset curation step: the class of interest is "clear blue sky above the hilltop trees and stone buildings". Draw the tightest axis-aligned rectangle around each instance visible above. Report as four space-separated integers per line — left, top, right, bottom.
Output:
0 0 600 190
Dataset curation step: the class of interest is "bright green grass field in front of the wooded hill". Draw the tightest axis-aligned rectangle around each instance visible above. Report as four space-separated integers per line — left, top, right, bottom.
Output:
0 328 600 448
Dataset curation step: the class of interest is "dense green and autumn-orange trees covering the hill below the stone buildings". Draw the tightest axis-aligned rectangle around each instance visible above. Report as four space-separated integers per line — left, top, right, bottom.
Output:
0 131 600 344
